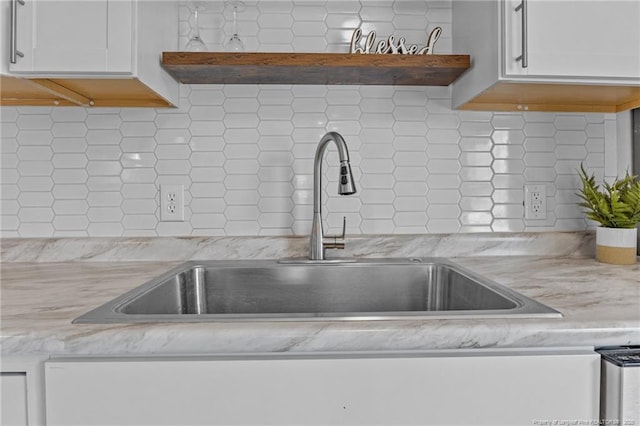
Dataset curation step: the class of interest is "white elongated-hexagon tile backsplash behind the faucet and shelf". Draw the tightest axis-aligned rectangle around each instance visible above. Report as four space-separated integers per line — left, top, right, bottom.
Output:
0 0 615 237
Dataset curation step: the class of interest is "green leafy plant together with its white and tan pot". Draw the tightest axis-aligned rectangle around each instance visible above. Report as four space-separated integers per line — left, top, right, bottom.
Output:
578 164 640 265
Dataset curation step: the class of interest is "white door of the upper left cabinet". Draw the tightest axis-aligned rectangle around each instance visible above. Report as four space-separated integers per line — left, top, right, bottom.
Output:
9 0 133 74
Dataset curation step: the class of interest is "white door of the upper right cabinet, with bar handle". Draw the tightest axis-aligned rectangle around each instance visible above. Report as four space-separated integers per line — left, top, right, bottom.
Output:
504 0 640 83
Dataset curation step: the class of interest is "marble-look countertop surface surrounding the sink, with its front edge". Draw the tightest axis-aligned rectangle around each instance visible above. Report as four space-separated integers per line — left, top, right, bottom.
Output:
0 250 640 355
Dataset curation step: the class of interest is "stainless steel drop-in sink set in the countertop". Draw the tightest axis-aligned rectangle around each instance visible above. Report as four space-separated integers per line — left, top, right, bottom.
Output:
74 258 561 323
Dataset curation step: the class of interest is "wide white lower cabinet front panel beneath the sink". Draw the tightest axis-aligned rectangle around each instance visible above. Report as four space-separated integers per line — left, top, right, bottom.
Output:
45 349 600 426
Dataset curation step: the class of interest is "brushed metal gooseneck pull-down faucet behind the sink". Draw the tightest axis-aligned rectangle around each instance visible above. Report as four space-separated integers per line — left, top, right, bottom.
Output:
309 132 356 260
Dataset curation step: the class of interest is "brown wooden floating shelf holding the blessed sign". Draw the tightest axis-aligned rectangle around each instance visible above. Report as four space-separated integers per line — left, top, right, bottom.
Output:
162 52 470 86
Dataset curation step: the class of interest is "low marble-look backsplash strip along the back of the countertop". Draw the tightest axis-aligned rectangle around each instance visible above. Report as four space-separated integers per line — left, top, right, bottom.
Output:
0 231 595 262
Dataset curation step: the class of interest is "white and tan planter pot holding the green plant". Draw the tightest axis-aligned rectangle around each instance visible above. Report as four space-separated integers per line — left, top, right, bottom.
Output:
596 227 638 265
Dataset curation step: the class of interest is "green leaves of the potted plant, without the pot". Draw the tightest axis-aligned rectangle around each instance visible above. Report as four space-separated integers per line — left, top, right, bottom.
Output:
577 164 640 228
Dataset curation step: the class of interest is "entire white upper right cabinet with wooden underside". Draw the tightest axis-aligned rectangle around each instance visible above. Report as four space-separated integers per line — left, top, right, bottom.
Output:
452 0 640 112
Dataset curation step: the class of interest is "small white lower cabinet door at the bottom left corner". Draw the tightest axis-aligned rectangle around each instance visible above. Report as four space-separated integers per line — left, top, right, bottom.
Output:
0 373 28 426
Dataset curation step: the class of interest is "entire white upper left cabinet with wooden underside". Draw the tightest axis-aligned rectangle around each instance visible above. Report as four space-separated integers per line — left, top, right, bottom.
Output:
0 0 180 107
